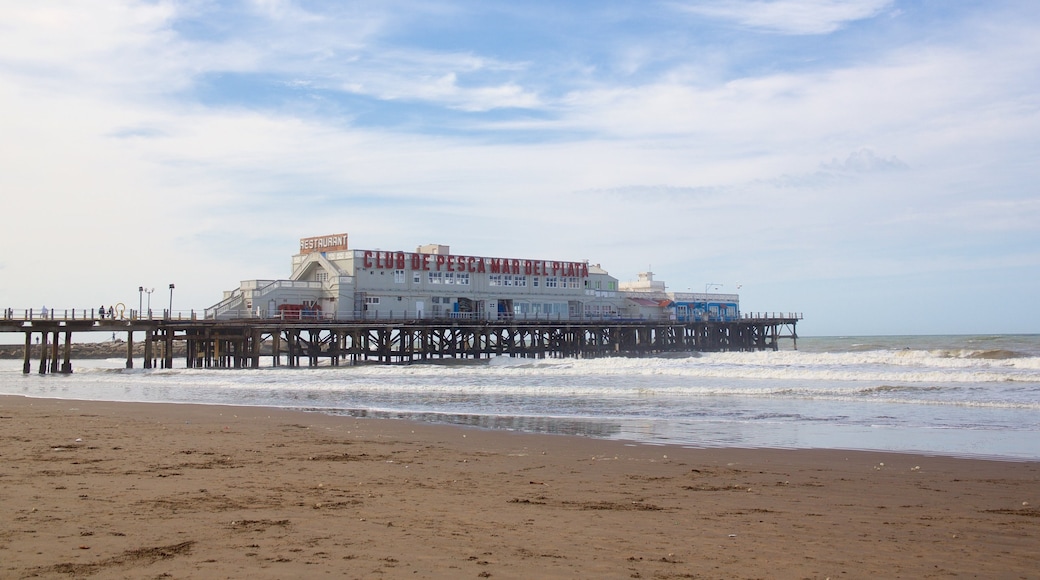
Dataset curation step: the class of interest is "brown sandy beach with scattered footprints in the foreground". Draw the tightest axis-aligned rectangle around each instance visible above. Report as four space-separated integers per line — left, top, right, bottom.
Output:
0 396 1040 579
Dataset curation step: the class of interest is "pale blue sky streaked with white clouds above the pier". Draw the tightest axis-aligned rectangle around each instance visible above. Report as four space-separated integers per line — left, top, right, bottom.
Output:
0 0 1040 336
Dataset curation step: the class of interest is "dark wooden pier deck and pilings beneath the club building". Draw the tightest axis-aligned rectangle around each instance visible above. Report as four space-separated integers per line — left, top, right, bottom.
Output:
0 312 801 374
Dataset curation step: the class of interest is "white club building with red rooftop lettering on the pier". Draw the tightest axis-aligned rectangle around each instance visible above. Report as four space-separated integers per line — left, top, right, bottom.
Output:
206 234 740 320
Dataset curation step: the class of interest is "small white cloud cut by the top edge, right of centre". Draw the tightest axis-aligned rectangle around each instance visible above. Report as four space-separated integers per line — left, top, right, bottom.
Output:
677 0 894 34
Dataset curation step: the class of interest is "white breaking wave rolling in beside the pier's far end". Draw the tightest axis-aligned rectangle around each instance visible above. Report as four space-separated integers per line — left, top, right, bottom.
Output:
22 351 1040 388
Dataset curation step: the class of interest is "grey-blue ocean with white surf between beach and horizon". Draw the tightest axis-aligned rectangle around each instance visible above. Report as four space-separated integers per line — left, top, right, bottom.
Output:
0 335 1040 460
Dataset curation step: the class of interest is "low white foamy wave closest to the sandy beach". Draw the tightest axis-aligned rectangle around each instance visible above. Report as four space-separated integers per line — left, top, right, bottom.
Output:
56 367 1040 411
